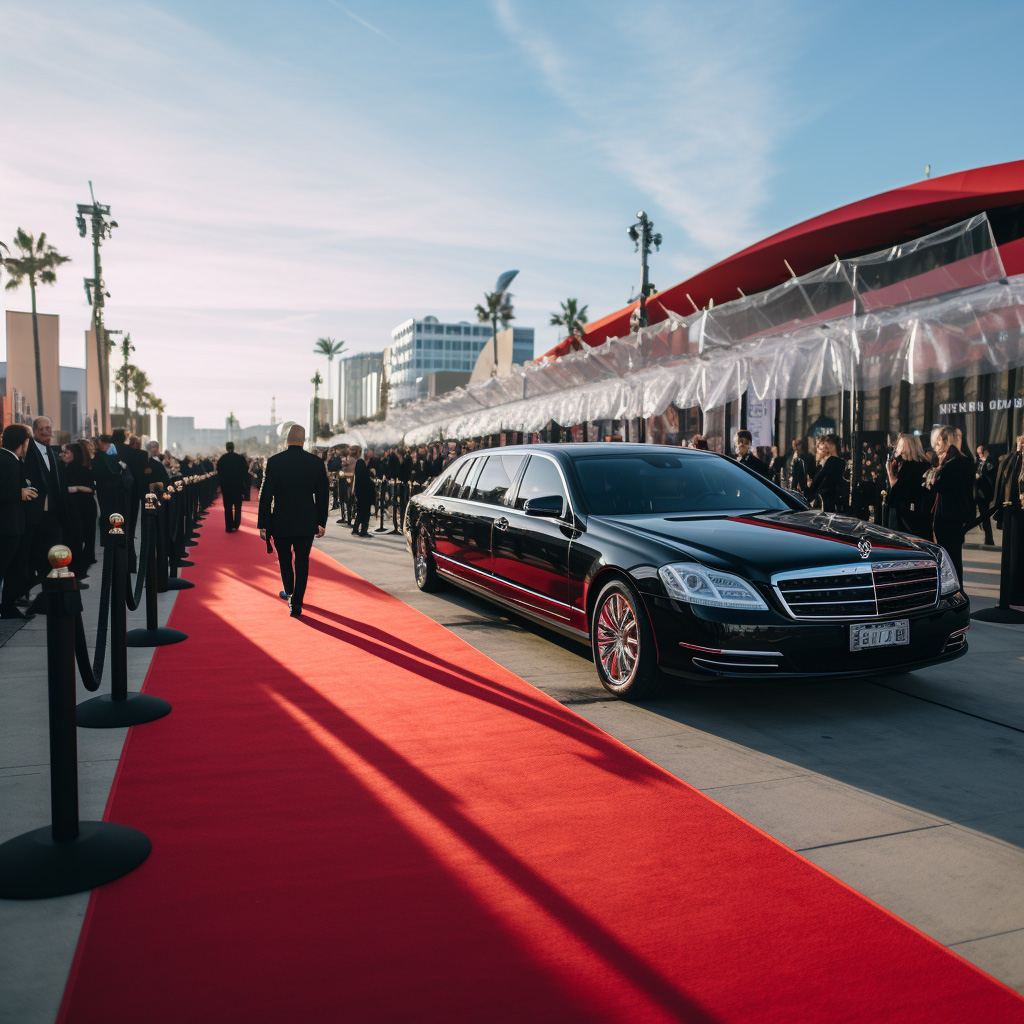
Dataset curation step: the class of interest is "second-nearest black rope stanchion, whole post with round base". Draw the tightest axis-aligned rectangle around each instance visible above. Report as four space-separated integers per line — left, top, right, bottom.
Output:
78 513 171 729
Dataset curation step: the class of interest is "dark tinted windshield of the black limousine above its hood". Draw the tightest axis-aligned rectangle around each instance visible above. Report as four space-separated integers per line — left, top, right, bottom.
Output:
574 452 791 515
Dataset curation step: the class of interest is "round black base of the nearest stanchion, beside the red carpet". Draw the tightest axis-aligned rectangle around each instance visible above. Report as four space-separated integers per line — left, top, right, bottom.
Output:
0 821 153 899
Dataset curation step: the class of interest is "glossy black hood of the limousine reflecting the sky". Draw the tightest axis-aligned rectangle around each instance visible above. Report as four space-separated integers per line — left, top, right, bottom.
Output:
602 510 935 582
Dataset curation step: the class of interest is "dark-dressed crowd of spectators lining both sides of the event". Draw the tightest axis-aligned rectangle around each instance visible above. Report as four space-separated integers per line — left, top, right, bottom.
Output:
8 417 1024 618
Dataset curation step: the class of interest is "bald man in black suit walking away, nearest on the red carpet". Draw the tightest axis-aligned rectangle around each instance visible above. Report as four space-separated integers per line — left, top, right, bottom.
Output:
257 423 330 618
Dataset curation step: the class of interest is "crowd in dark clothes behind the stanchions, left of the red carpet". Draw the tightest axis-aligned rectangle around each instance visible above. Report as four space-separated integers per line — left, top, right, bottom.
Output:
0 416 213 618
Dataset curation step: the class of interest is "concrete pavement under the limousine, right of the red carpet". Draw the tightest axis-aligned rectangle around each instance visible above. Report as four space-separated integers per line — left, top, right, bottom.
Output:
310 520 1024 992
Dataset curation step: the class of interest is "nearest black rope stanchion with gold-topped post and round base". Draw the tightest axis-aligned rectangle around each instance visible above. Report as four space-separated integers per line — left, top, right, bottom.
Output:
0 544 150 899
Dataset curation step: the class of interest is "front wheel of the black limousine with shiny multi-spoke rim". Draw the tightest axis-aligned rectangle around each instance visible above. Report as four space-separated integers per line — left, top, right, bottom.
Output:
590 580 667 700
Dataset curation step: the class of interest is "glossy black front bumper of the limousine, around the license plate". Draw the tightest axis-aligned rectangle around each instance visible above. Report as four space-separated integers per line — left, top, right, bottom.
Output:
644 592 971 681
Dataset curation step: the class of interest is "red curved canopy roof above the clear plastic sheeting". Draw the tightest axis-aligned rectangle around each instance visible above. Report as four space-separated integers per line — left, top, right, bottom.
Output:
545 160 1024 356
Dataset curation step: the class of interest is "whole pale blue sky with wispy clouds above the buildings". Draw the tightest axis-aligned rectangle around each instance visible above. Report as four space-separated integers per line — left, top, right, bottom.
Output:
0 0 1024 426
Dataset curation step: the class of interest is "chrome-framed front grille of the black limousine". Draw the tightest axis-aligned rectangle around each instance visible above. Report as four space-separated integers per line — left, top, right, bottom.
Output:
772 560 939 618
